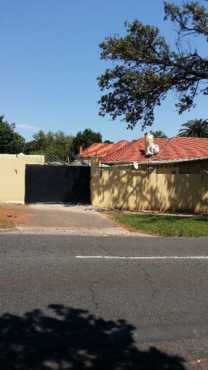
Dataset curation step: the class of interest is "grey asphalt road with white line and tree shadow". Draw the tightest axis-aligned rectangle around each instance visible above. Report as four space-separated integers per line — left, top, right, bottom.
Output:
0 234 208 370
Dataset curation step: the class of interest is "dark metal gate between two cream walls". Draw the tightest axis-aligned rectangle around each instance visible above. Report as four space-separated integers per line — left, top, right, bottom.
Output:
25 165 90 204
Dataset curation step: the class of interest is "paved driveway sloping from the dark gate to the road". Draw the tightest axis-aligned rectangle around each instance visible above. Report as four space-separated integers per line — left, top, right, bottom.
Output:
0 204 131 236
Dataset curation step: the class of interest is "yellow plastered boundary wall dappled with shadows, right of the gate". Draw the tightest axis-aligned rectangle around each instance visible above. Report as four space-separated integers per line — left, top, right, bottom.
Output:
91 162 208 214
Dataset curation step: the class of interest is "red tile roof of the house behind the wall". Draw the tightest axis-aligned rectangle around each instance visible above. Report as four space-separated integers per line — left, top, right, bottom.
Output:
81 137 208 163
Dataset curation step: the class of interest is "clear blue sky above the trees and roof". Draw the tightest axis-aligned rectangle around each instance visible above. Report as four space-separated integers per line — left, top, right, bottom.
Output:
0 0 207 140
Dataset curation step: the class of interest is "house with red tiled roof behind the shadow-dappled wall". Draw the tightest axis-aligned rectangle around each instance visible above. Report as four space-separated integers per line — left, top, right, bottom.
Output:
80 136 208 174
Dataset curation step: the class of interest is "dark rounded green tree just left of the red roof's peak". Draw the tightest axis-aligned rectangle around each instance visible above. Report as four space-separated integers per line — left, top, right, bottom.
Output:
72 128 102 155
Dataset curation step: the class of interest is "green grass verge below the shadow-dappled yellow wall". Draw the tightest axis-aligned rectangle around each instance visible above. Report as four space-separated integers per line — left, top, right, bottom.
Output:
111 212 208 237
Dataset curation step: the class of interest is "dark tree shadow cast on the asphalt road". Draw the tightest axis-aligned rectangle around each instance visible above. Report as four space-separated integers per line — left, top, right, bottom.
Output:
0 305 185 370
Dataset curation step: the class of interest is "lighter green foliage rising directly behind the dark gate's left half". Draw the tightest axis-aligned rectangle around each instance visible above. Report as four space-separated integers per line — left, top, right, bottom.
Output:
25 130 73 161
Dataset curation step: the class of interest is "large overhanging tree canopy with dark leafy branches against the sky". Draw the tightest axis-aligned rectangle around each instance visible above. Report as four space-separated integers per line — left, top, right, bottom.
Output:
98 0 208 128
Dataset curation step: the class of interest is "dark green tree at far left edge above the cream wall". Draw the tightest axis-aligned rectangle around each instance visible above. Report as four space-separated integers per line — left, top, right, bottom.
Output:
0 116 25 154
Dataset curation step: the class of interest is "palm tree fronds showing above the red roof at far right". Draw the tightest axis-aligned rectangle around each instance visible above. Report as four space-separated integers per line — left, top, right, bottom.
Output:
178 119 208 137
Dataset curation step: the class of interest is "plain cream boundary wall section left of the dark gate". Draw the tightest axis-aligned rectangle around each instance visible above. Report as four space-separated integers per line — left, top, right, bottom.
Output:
0 154 45 204
